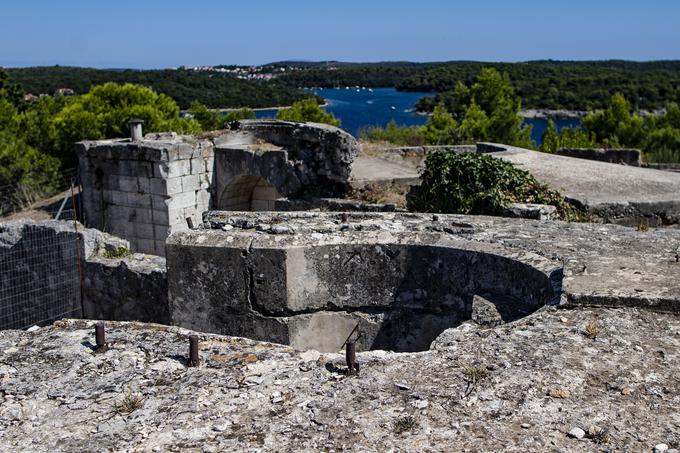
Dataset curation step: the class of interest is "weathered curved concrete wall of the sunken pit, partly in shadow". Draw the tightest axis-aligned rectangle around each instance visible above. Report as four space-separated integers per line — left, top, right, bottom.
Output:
168 230 557 351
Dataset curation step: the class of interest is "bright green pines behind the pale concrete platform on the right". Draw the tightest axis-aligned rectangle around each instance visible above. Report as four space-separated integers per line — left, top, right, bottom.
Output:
362 68 680 163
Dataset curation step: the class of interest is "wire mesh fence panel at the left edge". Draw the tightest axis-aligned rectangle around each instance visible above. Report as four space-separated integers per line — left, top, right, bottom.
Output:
0 214 82 329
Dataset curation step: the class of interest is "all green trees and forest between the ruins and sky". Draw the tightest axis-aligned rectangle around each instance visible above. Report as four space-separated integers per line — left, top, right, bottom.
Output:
0 62 680 215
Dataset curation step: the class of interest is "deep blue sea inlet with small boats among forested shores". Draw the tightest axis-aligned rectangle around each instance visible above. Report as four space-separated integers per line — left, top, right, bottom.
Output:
256 87 581 144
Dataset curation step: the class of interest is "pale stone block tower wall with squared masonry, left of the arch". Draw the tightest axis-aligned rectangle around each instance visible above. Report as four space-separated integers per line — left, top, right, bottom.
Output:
76 134 213 256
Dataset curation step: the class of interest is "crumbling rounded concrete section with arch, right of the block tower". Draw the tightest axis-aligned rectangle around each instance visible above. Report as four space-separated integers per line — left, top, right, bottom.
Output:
213 120 359 210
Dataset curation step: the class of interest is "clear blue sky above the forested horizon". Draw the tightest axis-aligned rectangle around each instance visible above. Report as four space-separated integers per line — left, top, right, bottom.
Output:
0 0 680 68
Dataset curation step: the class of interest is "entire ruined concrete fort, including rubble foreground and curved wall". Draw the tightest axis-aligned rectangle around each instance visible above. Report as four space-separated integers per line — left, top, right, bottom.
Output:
0 121 680 453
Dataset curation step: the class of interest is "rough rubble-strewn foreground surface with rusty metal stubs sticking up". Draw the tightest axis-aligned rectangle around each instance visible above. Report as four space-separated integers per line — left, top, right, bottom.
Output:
0 307 680 452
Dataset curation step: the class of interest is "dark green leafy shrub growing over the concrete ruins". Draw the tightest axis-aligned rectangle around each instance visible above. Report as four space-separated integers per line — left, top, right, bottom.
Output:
407 152 587 220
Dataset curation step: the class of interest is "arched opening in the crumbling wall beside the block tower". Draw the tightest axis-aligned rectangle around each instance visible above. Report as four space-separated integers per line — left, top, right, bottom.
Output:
217 175 281 211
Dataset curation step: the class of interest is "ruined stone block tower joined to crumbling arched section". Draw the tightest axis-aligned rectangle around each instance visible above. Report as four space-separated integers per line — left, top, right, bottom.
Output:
76 121 359 256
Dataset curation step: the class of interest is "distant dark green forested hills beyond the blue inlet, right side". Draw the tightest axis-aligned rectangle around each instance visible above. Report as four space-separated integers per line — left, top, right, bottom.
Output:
279 60 680 112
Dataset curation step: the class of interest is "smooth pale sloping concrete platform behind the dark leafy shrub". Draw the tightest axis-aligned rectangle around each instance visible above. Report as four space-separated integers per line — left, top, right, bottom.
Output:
352 143 680 226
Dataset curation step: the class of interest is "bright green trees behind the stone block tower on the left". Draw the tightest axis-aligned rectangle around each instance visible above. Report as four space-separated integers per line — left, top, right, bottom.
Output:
0 69 332 214
